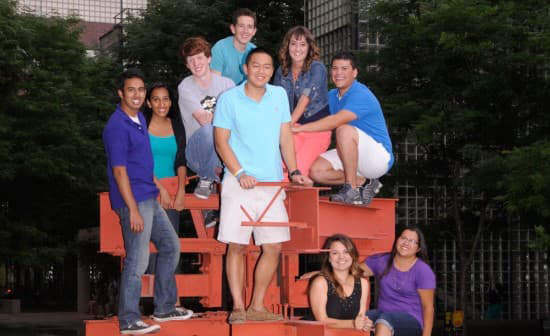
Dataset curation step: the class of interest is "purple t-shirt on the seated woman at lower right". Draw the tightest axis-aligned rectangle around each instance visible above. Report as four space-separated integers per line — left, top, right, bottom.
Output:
365 254 435 328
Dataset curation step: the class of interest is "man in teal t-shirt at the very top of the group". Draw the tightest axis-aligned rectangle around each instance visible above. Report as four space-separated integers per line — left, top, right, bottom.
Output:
210 8 256 85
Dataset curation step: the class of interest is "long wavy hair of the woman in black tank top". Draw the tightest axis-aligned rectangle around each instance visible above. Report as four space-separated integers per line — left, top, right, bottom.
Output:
320 233 362 297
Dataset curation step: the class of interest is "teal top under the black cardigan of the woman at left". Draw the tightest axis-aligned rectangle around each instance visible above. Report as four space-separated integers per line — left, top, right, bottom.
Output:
149 133 178 178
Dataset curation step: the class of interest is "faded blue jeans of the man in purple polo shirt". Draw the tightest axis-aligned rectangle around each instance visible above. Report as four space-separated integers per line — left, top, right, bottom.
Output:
116 198 180 329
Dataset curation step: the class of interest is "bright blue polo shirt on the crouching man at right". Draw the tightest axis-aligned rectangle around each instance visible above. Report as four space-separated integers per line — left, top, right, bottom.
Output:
328 81 394 169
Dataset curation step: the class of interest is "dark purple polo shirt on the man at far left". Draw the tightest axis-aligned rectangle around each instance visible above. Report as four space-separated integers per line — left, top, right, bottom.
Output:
103 105 159 210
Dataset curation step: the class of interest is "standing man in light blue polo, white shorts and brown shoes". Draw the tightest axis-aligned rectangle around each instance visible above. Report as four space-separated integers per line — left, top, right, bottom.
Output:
214 48 311 323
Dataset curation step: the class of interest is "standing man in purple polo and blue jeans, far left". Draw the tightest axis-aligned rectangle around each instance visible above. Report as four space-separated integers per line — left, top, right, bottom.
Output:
103 69 193 334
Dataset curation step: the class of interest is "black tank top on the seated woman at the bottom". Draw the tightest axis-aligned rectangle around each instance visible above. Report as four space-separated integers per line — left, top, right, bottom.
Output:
326 279 361 320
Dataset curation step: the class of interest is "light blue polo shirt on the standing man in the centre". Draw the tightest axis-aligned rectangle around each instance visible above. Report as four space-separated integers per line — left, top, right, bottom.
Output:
214 82 290 182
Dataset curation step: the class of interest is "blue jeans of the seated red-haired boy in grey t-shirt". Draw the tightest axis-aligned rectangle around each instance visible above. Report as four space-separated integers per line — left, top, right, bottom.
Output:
185 125 222 182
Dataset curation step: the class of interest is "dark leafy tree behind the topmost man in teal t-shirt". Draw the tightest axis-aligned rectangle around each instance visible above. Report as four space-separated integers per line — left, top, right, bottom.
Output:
123 0 303 87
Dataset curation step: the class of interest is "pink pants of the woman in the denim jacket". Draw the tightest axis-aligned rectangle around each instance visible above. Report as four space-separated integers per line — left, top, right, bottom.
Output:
283 131 331 181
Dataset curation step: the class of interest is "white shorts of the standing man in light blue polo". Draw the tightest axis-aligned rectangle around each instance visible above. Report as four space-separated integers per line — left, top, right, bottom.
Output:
218 174 290 245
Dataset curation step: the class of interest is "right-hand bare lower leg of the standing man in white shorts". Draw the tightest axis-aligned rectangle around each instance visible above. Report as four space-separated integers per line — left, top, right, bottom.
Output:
250 243 282 311
